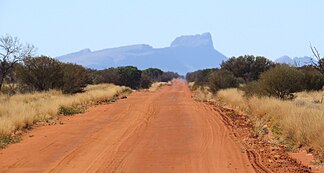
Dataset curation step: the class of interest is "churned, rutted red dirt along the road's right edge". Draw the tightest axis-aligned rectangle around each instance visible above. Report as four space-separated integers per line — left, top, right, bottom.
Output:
210 102 316 173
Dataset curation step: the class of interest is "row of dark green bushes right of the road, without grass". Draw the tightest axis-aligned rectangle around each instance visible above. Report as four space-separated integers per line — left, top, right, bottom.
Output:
186 55 324 99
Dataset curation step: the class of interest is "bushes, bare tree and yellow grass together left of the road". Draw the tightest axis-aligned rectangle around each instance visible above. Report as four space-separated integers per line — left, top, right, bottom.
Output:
0 35 179 148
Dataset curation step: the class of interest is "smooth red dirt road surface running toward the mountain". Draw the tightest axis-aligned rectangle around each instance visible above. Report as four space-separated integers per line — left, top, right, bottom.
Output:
0 80 254 173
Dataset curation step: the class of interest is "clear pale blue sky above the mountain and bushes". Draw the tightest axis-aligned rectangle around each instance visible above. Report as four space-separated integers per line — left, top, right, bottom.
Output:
0 0 324 59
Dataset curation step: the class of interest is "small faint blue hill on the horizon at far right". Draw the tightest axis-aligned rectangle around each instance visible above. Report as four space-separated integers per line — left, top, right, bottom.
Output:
275 56 314 67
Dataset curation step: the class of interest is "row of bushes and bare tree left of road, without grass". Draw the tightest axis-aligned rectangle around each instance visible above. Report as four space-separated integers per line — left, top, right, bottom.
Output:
0 35 179 95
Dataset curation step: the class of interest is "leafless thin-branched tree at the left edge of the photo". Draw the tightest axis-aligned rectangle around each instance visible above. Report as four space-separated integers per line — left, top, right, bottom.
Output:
0 35 35 90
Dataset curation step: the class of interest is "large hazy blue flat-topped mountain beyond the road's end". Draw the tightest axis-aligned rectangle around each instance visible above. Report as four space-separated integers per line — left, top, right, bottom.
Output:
57 33 227 74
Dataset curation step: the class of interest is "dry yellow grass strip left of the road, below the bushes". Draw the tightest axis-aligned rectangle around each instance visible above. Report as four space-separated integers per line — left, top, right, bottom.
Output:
0 84 129 137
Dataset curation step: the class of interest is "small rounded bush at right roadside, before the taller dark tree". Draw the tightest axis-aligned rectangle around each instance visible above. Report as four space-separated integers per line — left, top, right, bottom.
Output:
208 70 239 93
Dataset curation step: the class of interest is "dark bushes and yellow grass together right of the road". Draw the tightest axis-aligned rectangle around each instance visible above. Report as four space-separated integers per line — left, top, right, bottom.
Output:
186 53 324 158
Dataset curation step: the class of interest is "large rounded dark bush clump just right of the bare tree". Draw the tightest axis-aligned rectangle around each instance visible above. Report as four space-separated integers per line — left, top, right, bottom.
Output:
16 56 88 94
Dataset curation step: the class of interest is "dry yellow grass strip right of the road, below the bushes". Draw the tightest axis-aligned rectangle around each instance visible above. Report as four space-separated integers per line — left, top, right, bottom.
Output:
217 89 324 154
